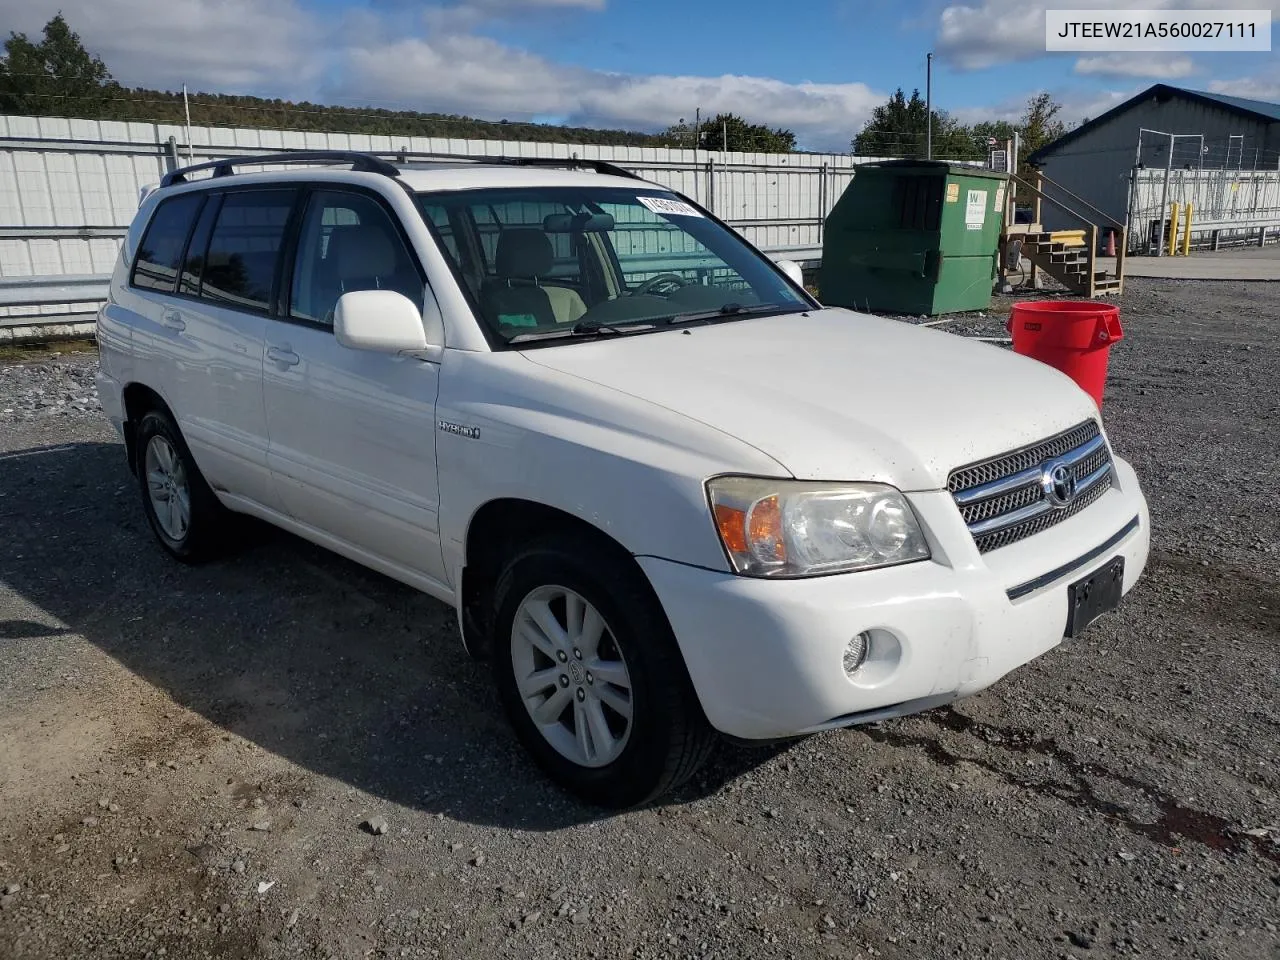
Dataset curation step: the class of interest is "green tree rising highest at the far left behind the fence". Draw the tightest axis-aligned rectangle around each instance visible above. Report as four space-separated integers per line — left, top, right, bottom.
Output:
0 13 115 116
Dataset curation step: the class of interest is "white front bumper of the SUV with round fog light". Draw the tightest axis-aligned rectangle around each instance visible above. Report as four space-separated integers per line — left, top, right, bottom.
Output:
639 458 1151 740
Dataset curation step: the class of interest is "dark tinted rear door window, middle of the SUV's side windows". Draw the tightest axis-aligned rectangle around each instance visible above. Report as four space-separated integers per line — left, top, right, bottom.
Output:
200 189 296 316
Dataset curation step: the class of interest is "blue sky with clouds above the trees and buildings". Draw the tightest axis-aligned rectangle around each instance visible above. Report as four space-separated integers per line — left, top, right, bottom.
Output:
0 0 1280 150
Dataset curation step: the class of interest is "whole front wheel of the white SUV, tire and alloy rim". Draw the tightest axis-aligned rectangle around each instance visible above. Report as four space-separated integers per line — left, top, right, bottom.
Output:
492 536 714 808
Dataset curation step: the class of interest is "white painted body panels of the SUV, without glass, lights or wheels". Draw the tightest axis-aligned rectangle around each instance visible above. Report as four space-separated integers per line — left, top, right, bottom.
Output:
99 165 1149 739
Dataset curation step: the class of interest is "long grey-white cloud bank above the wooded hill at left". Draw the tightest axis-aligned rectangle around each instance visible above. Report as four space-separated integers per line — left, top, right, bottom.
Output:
0 0 887 151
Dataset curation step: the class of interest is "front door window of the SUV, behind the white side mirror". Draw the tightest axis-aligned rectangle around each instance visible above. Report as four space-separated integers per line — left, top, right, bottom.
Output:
289 191 426 326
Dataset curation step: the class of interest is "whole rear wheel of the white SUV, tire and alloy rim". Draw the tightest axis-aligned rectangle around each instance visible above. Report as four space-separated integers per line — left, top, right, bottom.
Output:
137 410 225 563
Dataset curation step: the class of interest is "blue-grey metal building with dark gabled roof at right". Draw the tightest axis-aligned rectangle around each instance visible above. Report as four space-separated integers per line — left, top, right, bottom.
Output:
1030 83 1280 240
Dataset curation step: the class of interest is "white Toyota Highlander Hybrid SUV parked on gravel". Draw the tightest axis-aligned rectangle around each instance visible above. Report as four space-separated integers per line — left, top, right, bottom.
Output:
97 154 1149 806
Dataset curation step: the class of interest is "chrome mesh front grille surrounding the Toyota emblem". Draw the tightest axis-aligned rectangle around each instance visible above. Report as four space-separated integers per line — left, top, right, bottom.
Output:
947 420 1112 553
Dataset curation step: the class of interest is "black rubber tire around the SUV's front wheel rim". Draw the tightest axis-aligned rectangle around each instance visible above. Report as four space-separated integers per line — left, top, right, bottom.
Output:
490 535 717 809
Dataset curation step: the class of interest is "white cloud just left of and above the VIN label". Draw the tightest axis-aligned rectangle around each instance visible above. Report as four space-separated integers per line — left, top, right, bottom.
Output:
934 0 1280 76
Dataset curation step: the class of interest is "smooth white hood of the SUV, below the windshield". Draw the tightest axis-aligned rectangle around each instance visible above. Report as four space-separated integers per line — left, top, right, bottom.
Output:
525 308 1098 490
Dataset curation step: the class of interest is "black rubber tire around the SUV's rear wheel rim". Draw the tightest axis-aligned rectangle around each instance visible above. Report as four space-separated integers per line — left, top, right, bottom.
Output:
134 410 229 563
